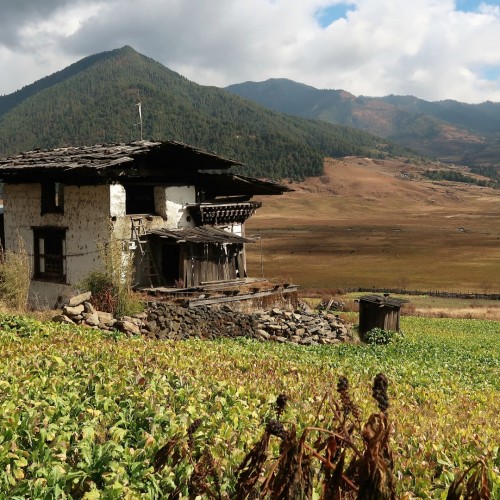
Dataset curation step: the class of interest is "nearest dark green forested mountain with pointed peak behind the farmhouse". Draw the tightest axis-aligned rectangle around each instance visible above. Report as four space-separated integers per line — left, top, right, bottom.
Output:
0 47 403 179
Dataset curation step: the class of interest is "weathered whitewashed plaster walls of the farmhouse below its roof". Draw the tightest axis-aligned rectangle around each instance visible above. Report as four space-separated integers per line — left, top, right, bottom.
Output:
4 184 248 306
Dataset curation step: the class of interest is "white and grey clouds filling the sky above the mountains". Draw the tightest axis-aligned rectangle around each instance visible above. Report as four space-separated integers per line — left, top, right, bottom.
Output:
0 0 500 102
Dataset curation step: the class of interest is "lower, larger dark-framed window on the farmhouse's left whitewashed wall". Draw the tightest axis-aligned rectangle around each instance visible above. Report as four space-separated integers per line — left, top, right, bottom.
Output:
33 228 66 283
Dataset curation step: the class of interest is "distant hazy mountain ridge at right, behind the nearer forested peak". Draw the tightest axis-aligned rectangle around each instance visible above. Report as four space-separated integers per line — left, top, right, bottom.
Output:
226 79 500 165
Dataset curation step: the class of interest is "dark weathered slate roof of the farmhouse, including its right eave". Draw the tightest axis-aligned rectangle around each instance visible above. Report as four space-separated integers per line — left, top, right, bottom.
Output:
0 141 291 197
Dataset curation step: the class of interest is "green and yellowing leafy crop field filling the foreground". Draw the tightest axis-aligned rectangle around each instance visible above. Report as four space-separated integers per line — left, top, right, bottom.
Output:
0 315 500 498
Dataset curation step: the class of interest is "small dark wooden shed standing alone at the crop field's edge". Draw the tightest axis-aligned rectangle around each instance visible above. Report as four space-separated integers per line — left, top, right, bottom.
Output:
359 294 408 335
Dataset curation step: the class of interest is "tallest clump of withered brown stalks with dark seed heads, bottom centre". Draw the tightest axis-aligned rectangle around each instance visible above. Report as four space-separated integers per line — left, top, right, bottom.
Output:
232 374 395 500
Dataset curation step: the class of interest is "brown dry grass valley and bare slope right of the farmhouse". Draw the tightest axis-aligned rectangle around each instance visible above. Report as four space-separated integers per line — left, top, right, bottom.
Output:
247 158 500 293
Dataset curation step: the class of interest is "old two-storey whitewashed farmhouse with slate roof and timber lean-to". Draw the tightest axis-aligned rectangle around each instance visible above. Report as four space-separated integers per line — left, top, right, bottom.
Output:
0 141 288 304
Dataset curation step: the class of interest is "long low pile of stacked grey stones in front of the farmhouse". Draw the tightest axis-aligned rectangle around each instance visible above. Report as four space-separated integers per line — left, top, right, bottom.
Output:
54 294 353 345
